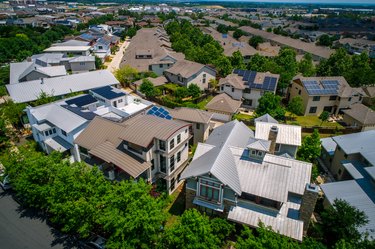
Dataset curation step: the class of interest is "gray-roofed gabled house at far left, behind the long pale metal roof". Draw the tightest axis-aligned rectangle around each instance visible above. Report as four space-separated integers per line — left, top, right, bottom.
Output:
9 61 67 84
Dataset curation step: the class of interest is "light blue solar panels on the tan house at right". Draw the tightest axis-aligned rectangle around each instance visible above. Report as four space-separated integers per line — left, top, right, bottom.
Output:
302 80 339 95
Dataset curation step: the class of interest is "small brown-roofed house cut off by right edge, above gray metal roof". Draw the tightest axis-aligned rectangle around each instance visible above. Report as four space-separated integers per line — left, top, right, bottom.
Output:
342 103 375 131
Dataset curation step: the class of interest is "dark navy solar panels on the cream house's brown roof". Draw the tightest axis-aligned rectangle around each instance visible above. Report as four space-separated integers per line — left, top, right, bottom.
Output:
233 69 277 91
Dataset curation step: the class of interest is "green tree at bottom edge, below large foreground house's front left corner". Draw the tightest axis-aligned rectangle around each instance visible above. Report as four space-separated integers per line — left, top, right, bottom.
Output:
160 209 233 249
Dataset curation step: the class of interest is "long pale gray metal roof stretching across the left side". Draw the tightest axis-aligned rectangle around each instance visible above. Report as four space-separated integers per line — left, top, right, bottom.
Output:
6 70 119 103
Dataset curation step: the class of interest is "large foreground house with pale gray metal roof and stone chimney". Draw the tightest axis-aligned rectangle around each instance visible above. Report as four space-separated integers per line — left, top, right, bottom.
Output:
181 120 318 241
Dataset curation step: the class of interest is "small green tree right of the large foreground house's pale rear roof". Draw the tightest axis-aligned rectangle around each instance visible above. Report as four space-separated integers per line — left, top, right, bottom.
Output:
297 129 321 163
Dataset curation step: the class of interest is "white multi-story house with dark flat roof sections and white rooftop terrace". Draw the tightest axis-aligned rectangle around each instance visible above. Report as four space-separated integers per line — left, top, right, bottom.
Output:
26 87 152 161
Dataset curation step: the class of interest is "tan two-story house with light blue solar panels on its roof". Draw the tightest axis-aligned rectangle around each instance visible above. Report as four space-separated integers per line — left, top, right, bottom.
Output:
287 76 366 116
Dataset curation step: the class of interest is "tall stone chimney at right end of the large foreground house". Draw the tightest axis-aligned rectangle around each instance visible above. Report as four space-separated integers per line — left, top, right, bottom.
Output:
299 183 319 232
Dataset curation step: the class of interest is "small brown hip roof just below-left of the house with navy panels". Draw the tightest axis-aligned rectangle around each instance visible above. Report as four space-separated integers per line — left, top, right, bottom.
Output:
206 93 242 113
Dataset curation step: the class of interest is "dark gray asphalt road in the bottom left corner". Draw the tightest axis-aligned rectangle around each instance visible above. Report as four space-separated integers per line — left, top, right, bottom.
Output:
0 190 77 249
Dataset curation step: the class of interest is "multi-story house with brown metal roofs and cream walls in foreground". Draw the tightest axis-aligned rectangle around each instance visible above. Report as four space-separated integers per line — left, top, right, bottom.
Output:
75 115 191 193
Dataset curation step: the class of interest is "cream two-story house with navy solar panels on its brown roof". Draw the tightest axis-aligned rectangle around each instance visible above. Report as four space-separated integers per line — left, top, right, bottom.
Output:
219 69 280 108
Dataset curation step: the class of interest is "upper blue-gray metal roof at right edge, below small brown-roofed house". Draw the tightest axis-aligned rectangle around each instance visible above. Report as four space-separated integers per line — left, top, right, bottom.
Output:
332 130 375 166
